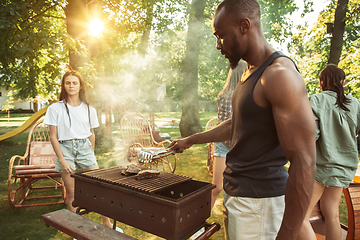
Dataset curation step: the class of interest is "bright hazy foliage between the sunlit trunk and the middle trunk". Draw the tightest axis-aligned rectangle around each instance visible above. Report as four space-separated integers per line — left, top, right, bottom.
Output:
86 0 191 105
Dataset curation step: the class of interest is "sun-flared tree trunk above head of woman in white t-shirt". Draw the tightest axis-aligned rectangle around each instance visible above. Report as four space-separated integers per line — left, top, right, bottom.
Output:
65 0 88 70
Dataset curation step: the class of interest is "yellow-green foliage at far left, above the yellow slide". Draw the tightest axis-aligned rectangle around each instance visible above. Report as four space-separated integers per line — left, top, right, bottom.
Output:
0 0 65 102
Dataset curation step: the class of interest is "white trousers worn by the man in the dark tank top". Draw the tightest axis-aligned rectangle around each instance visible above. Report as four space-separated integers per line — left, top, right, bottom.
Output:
223 191 285 240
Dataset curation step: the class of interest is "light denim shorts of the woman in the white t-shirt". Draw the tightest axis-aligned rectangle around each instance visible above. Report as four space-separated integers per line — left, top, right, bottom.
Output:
55 138 97 172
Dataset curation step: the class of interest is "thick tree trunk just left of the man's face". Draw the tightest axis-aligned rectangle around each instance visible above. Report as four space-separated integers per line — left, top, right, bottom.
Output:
180 0 206 137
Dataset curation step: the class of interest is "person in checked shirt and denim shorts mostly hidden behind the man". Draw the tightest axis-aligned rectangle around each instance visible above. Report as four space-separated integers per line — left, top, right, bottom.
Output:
211 61 247 208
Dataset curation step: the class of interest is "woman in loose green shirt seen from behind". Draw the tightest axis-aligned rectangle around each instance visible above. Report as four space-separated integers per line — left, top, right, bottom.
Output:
299 64 360 240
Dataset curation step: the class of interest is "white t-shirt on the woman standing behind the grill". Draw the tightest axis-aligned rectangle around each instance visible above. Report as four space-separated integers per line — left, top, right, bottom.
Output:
44 101 100 141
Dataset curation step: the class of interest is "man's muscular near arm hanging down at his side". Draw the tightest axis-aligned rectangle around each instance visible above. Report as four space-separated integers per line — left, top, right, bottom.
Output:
262 58 316 240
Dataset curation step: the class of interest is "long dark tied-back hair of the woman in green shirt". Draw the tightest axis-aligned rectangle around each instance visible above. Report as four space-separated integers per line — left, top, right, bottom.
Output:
319 64 351 111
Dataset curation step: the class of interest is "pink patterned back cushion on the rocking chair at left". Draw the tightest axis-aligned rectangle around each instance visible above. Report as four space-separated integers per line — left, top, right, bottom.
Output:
29 141 55 165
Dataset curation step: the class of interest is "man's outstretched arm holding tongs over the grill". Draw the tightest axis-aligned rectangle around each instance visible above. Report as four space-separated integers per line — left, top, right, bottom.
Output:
168 118 231 153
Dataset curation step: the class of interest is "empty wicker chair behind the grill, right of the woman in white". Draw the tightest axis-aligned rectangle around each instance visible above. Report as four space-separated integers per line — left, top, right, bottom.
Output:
120 112 177 173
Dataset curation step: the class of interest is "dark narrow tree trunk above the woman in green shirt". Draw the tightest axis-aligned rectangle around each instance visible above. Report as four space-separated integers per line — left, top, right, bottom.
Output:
328 0 349 65
